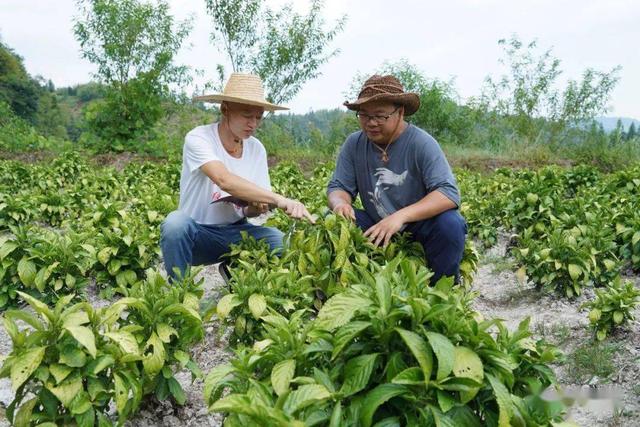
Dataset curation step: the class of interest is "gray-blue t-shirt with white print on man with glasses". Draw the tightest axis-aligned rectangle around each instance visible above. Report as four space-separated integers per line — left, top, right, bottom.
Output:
327 125 460 221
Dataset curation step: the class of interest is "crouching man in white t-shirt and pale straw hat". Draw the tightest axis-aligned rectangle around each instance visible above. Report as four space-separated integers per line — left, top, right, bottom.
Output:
160 73 313 278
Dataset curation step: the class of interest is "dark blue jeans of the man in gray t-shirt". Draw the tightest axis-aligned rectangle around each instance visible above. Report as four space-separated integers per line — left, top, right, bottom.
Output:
355 209 467 284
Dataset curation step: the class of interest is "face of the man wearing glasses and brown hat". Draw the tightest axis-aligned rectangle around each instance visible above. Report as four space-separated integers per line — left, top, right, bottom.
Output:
358 102 403 143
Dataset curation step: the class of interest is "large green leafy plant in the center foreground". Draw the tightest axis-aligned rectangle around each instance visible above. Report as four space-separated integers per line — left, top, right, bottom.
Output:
205 258 562 426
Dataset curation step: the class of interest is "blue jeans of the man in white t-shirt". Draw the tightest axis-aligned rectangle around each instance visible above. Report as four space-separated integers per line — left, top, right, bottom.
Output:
160 211 283 279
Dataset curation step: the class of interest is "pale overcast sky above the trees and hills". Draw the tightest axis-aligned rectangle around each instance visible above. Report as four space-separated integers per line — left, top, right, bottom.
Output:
0 0 640 119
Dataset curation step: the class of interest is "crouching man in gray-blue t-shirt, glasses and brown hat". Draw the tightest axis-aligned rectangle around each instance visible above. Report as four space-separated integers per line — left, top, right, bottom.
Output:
327 75 466 283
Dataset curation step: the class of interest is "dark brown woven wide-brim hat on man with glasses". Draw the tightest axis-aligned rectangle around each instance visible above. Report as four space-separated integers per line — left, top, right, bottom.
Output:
343 74 420 116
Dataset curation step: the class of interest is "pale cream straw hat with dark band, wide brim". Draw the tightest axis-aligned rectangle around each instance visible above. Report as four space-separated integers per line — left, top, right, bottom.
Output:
193 73 288 111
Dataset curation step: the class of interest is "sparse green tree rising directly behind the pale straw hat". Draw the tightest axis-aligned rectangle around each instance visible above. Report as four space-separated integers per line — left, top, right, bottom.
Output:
205 0 346 103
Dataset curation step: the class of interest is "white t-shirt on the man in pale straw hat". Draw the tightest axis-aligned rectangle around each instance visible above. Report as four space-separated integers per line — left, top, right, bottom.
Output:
178 123 271 225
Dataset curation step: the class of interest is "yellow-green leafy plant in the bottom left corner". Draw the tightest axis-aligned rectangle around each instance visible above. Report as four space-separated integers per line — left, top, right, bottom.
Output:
0 293 142 426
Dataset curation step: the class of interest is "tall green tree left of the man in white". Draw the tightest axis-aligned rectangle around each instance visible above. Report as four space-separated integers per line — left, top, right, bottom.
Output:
74 0 190 146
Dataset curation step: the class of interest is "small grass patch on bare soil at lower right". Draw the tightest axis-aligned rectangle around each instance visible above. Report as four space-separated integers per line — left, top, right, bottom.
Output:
567 341 621 384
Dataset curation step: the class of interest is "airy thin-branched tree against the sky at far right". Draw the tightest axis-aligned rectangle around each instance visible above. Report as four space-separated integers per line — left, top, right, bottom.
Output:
481 35 620 139
